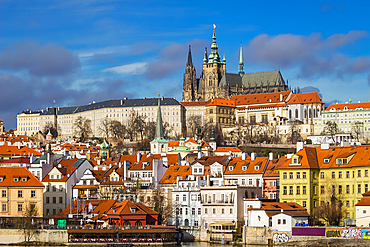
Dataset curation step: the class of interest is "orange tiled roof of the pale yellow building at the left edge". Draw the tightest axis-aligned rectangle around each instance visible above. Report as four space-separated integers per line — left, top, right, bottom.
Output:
0 167 44 188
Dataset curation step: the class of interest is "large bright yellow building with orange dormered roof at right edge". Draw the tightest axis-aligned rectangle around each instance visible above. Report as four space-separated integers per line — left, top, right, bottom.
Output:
279 145 370 224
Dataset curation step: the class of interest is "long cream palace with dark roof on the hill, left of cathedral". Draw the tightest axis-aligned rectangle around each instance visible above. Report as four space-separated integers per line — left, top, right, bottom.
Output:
17 97 185 138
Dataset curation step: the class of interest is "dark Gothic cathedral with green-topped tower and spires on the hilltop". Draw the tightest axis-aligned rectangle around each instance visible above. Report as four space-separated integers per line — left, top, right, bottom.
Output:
182 29 289 101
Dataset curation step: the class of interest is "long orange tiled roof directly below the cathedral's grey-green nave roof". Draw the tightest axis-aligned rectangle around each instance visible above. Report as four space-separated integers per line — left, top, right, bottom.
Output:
231 91 291 106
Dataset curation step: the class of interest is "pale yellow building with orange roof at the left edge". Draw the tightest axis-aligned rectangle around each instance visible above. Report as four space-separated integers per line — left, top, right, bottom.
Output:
0 167 44 216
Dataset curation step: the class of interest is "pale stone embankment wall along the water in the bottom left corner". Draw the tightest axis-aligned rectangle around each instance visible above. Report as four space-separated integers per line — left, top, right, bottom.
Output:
0 229 68 244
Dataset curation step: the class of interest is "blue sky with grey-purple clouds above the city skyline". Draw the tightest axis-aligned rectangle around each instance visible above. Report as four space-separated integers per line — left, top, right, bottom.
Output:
0 0 370 129
